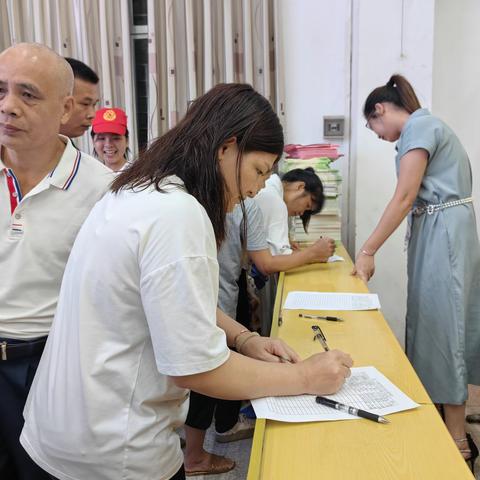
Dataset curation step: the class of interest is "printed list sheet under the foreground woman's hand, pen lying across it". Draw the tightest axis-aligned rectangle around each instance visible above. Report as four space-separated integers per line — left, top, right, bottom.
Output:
252 367 418 422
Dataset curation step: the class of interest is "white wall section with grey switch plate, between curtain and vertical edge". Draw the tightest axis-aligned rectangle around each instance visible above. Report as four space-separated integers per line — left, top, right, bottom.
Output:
276 0 350 248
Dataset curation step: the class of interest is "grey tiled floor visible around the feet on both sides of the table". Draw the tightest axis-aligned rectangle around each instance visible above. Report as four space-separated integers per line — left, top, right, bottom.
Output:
179 387 480 480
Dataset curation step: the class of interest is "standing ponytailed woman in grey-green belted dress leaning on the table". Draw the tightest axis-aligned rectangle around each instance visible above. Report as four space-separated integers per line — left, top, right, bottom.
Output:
354 75 480 465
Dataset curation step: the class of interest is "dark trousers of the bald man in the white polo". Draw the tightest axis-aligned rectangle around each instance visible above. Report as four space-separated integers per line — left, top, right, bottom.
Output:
0 338 51 480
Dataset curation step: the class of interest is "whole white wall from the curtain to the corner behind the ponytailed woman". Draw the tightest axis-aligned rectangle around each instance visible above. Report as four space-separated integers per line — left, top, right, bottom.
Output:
277 0 434 342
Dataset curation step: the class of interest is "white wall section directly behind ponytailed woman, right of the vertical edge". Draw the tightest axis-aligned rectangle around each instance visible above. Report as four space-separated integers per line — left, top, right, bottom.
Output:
351 0 434 344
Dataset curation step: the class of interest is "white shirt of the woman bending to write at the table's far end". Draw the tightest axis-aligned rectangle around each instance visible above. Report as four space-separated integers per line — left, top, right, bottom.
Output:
255 173 292 255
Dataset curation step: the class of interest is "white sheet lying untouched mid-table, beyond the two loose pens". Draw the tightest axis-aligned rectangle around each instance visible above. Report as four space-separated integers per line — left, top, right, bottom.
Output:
283 292 380 310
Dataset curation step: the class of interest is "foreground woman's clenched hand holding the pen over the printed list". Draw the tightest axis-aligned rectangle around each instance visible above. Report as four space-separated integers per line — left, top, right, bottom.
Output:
298 350 353 395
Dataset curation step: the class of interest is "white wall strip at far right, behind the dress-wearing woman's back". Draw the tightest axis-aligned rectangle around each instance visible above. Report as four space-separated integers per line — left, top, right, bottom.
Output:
432 0 480 239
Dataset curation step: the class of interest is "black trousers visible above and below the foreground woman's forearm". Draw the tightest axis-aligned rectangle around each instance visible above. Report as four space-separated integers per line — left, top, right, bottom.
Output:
185 270 250 433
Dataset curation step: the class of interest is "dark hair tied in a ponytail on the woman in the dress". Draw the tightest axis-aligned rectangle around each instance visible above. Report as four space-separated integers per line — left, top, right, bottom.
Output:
363 74 422 118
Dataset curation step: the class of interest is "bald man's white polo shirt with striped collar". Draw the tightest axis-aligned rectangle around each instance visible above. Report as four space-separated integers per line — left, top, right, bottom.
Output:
0 135 113 340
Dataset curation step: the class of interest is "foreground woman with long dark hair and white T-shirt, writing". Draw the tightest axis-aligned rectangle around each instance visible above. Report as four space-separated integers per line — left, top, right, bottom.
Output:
21 84 352 480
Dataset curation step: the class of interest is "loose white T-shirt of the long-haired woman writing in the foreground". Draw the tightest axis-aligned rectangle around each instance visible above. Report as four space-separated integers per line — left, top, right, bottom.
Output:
21 177 229 480
